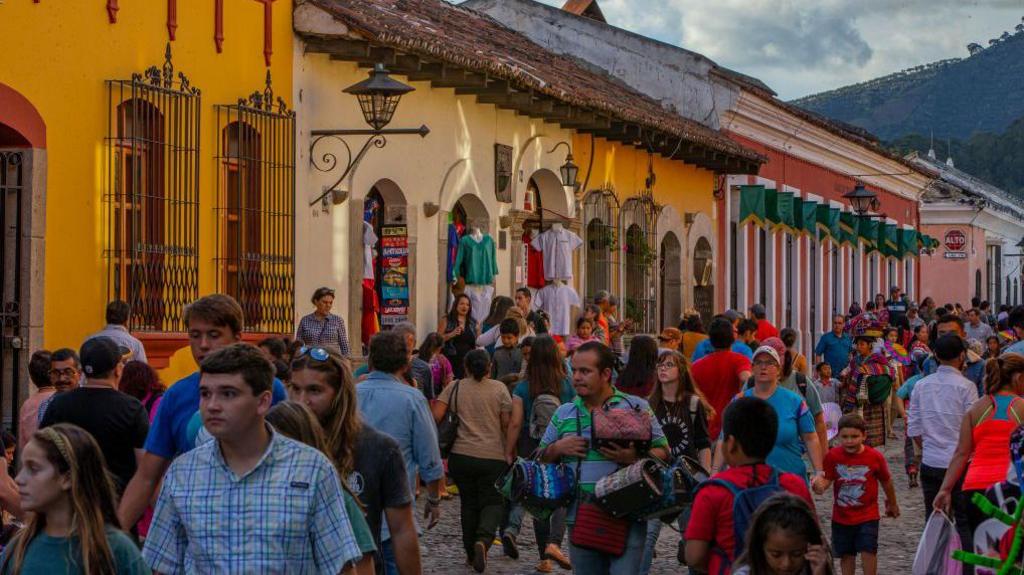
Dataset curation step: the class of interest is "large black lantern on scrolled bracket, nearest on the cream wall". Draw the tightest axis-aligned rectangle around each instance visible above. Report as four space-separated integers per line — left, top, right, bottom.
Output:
309 63 430 206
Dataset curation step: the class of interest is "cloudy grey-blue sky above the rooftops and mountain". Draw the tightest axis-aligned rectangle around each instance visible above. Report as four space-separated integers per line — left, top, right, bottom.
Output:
528 0 1024 99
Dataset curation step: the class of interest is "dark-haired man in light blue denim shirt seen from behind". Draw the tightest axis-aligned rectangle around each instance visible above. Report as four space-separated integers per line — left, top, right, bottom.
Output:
355 329 444 574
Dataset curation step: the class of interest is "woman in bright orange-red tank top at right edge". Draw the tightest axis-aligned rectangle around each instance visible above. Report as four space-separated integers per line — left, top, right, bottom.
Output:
933 353 1024 536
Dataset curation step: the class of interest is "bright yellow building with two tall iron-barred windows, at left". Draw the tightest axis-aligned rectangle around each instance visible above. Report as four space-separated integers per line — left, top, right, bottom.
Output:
0 0 295 401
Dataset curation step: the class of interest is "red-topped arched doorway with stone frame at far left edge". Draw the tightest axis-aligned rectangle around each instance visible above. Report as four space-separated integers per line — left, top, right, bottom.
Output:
0 84 46 429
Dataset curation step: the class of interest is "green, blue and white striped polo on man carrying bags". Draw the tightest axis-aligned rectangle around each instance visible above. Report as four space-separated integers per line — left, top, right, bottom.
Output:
541 390 669 493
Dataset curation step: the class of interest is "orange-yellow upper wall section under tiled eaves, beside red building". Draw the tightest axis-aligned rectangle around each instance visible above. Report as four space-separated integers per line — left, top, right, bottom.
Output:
572 134 715 222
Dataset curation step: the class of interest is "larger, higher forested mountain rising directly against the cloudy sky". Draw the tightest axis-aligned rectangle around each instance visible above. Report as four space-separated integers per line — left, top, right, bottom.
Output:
793 25 1024 140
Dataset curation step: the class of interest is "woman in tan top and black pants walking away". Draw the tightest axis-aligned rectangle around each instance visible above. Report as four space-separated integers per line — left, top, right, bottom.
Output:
430 349 512 573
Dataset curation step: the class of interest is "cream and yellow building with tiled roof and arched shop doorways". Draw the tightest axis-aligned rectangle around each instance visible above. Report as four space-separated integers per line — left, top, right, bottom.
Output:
294 0 759 349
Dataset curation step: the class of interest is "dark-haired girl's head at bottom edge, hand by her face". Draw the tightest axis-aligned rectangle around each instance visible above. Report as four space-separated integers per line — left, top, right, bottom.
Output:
732 493 835 575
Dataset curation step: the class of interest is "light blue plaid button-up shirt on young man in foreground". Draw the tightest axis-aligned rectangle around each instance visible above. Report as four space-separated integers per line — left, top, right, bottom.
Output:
142 426 362 575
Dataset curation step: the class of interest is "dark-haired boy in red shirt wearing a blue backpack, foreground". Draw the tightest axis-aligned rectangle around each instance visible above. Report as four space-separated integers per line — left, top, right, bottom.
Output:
684 397 814 574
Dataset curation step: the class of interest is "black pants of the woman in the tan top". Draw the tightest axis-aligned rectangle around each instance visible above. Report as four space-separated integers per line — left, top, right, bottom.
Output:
449 453 508 558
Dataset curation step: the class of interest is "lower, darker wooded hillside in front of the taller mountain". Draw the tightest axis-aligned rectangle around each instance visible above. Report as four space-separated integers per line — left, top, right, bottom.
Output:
889 118 1024 197
